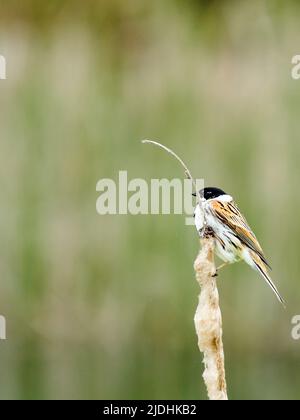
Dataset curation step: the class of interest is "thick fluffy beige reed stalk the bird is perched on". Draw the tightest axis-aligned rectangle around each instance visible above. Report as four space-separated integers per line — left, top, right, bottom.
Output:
194 235 228 400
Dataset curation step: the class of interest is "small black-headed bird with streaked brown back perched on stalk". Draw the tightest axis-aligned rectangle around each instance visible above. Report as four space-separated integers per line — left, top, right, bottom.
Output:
193 187 284 305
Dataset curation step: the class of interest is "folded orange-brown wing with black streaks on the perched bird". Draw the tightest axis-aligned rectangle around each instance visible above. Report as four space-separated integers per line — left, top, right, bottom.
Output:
211 200 271 268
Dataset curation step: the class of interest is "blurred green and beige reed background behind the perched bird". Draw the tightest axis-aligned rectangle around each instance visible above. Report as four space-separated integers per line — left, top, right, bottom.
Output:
0 0 300 399
